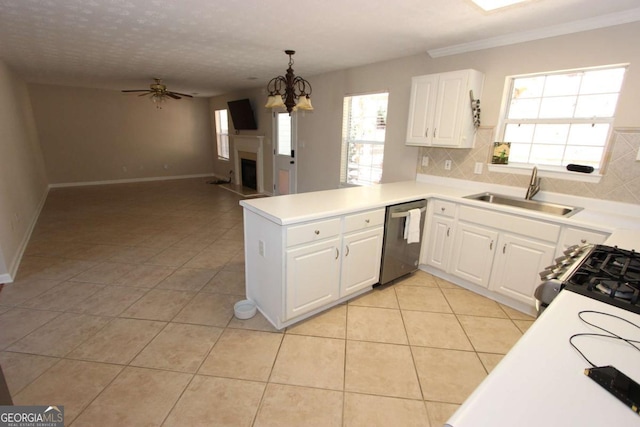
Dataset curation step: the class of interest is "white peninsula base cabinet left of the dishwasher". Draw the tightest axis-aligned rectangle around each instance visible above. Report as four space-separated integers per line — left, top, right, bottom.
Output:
244 209 385 329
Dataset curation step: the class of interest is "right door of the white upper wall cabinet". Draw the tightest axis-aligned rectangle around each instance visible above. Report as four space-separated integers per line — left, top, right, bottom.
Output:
432 70 471 147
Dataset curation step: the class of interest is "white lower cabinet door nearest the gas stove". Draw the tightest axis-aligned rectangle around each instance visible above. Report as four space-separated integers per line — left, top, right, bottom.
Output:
490 233 555 306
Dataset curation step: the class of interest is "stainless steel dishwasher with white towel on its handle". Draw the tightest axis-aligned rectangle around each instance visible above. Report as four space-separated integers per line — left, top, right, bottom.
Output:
380 199 427 285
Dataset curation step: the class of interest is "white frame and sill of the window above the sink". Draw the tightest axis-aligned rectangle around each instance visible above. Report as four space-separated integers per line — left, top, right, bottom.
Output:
488 63 629 182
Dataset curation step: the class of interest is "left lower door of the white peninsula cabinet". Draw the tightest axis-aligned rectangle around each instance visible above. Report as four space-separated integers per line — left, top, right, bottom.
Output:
285 237 340 320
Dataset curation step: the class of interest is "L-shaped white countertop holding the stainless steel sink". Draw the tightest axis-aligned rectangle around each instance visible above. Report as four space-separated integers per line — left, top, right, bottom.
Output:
240 175 640 232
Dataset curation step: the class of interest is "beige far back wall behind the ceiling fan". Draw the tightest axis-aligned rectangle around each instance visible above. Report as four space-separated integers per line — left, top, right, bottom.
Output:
29 84 215 184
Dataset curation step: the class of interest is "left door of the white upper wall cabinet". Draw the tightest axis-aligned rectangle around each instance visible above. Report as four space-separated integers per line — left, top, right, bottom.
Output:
407 75 438 145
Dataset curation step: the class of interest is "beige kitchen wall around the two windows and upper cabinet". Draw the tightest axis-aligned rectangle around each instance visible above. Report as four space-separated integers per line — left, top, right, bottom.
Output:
211 23 640 199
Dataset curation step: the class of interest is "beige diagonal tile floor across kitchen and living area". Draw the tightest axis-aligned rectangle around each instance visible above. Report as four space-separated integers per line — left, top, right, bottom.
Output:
0 179 533 427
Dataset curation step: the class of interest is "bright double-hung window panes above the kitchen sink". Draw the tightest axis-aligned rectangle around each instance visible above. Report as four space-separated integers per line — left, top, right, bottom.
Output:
498 65 626 175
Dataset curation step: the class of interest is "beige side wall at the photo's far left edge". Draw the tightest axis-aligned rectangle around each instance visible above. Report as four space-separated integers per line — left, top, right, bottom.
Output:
0 61 47 283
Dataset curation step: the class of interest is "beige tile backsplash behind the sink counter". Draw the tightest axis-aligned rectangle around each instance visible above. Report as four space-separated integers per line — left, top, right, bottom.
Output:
418 127 640 204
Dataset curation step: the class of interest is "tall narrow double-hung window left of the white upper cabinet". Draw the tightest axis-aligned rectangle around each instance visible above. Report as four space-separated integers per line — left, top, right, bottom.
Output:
340 92 389 185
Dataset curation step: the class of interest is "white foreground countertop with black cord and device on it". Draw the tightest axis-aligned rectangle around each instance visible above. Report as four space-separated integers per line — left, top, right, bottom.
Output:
447 291 640 427
